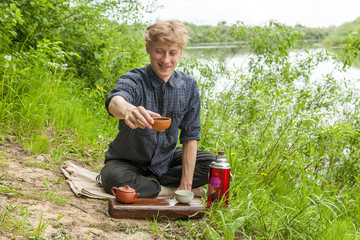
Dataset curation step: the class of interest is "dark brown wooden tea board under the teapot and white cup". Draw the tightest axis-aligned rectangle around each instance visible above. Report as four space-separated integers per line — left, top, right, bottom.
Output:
109 198 205 219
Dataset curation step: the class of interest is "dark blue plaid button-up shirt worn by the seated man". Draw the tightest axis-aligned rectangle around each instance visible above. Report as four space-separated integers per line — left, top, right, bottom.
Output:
105 65 201 177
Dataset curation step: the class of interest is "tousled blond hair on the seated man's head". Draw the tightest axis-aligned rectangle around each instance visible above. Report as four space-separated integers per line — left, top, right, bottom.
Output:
145 20 189 48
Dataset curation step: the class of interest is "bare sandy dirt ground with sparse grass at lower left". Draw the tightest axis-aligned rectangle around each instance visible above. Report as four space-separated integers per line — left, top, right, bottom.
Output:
0 136 188 239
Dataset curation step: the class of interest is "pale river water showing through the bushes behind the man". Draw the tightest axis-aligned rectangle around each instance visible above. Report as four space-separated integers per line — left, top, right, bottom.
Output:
184 44 360 124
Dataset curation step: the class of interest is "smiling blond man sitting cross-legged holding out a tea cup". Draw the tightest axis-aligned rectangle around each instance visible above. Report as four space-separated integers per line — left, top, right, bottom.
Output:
100 20 215 198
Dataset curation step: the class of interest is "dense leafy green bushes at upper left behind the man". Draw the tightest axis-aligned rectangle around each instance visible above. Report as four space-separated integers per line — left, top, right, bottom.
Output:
0 0 151 87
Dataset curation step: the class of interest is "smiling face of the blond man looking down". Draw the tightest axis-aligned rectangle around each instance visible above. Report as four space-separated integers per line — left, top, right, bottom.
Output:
146 42 183 82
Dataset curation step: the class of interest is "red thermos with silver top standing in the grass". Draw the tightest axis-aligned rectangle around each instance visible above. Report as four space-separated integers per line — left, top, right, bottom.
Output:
207 152 231 207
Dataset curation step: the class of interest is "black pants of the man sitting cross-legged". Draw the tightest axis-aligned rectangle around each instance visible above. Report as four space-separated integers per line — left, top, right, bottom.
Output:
100 147 215 198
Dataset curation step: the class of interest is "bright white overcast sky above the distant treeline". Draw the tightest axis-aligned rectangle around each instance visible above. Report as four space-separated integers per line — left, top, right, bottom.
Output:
149 0 360 27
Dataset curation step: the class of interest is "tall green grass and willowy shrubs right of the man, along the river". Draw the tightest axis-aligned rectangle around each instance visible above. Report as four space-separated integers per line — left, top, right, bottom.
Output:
183 23 360 239
